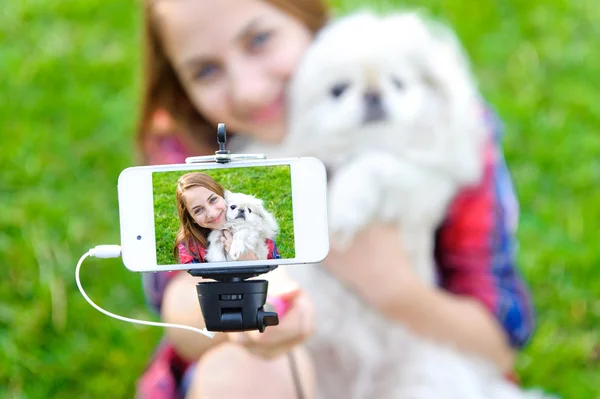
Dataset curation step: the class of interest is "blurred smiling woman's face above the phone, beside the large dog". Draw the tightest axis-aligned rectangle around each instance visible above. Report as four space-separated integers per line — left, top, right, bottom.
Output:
155 0 312 143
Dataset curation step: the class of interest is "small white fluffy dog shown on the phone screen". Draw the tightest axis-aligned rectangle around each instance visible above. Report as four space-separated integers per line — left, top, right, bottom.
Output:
206 190 279 262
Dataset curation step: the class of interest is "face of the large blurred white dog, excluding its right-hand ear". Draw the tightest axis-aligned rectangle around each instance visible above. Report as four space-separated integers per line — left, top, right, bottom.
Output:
291 16 427 137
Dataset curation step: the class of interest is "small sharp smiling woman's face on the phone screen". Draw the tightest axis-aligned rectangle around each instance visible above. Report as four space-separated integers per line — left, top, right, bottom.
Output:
183 186 227 230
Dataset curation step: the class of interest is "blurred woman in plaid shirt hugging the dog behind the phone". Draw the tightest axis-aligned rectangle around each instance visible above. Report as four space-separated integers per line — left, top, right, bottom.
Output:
140 0 533 398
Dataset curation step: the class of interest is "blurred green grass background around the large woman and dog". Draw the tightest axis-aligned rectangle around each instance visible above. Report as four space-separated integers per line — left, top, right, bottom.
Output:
0 0 600 398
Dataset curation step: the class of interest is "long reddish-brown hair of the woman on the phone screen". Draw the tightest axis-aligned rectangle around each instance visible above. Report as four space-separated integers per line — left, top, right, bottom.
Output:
173 172 225 262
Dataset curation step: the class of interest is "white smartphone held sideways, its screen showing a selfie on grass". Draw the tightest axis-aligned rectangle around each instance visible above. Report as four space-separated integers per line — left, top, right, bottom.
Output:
118 158 329 272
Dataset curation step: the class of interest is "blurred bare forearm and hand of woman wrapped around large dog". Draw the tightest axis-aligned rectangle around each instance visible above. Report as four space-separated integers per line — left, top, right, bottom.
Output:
324 225 514 370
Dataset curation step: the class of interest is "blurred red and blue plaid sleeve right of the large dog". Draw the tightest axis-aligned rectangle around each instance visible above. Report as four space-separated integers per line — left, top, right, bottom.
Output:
436 111 534 348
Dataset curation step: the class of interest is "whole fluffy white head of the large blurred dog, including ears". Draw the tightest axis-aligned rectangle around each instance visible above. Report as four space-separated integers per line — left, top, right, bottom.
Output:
289 13 482 178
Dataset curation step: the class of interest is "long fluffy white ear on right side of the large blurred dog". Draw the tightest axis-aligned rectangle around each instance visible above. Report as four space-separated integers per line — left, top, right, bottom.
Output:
390 13 486 182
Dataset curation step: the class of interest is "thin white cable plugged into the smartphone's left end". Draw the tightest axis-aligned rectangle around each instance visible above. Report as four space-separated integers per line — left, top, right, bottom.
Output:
75 245 215 339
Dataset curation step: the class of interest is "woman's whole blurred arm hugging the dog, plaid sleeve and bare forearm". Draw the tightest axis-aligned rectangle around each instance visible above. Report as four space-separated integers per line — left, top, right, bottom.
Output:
325 133 533 371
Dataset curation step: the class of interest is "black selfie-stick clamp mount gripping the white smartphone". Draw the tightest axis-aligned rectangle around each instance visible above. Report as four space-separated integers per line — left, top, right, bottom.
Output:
185 123 279 332
